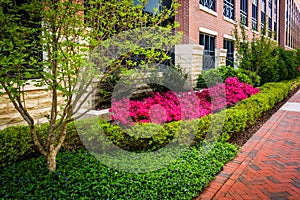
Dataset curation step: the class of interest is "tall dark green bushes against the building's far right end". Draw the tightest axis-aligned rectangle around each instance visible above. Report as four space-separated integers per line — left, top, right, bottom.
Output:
234 26 300 85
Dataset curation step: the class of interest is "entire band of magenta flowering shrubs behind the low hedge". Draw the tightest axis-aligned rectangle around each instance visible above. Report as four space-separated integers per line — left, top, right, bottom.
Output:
110 77 259 126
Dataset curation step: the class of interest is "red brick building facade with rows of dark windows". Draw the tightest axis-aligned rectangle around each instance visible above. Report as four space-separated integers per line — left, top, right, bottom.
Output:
177 0 300 72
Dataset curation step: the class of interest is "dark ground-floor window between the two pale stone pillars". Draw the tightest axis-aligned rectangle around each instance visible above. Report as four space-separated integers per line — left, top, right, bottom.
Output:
199 33 216 70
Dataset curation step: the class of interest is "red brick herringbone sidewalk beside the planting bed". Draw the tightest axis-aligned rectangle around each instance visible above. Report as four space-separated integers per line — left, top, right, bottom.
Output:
198 91 300 200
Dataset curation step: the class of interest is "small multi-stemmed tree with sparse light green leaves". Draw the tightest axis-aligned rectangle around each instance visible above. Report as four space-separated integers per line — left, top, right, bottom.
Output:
0 0 178 172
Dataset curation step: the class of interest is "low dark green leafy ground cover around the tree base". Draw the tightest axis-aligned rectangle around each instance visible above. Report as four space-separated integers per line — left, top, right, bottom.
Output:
0 143 237 199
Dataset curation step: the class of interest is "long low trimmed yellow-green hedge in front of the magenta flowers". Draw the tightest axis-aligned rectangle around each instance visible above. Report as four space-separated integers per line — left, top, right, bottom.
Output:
0 80 299 166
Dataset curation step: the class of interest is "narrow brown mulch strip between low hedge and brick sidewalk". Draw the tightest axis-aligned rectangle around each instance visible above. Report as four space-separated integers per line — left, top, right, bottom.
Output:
229 85 300 147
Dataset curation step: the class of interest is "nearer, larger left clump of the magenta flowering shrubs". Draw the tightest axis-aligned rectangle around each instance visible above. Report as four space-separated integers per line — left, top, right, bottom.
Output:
110 91 210 125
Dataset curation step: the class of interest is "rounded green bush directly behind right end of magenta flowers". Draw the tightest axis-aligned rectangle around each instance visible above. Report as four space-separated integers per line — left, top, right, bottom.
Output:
197 66 260 88
